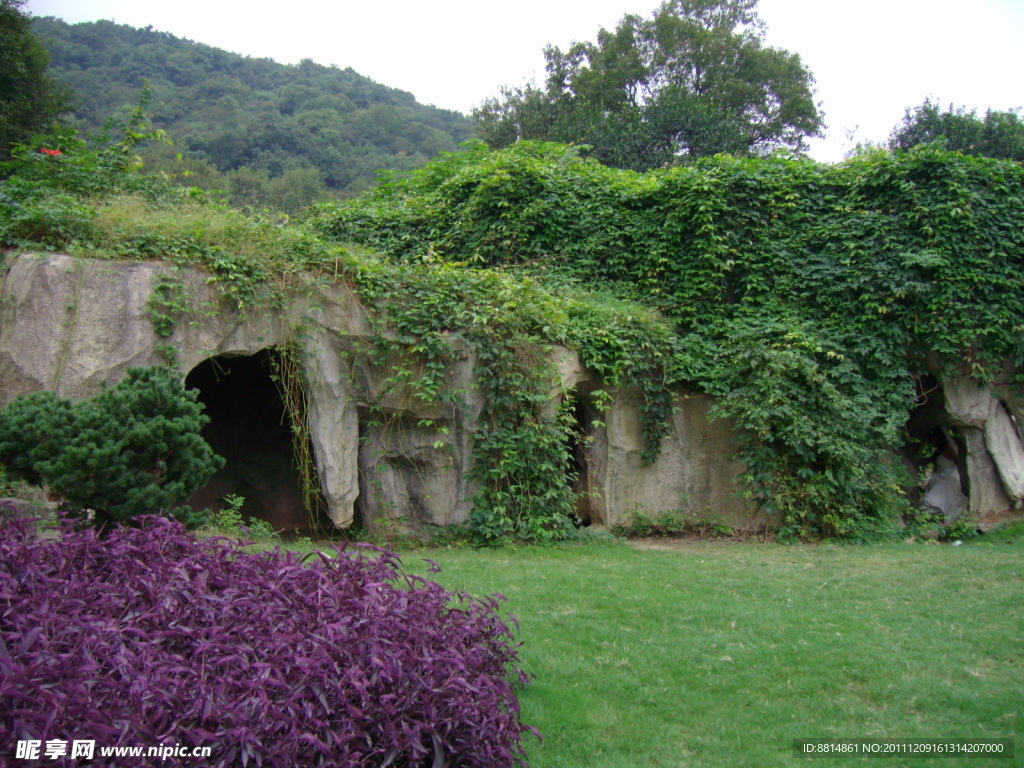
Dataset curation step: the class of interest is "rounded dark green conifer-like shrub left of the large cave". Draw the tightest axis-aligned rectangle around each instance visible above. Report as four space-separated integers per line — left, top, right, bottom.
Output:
0 368 223 525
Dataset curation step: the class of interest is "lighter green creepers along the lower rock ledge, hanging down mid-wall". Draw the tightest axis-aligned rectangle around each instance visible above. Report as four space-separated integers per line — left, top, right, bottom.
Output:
0 117 672 543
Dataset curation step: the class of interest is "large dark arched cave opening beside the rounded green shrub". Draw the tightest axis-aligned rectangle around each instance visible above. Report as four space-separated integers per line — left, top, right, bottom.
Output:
185 349 324 537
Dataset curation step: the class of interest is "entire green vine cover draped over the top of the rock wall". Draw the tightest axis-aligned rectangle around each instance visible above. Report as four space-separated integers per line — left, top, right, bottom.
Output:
8 88 1024 542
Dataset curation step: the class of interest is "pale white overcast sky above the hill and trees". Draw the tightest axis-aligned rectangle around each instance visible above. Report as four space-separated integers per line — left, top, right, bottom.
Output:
25 0 1024 162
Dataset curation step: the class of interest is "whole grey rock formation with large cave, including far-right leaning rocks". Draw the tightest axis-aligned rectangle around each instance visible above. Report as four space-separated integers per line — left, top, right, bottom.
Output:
8 254 1024 530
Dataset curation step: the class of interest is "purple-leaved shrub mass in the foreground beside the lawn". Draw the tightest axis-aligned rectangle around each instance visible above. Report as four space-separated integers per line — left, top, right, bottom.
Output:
0 518 536 768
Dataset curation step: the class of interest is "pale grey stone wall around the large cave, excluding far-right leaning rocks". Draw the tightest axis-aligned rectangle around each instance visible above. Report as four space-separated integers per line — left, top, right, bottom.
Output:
0 254 765 528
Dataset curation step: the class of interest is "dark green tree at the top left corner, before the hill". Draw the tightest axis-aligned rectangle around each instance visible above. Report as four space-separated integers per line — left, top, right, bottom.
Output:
0 0 71 159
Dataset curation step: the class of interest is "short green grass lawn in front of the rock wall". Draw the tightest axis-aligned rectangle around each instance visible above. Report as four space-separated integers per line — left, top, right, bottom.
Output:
387 535 1024 768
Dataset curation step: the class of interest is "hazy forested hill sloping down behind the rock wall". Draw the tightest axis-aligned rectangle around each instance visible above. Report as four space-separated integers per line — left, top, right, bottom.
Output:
33 17 473 210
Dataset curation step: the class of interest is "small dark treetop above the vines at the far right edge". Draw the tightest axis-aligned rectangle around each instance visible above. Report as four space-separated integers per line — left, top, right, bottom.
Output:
889 99 1024 162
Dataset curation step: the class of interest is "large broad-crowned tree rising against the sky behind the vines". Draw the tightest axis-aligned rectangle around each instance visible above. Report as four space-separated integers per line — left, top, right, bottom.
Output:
473 0 823 170
